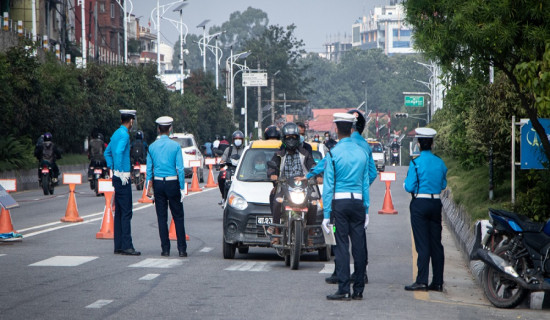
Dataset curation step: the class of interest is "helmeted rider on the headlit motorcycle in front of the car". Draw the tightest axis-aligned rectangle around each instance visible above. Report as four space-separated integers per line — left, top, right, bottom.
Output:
267 122 317 244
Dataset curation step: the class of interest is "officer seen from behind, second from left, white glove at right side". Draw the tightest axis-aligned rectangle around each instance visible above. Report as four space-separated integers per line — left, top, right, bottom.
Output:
147 116 187 257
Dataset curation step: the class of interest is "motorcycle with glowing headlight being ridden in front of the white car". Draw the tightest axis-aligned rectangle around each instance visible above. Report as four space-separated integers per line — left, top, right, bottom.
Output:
264 169 330 270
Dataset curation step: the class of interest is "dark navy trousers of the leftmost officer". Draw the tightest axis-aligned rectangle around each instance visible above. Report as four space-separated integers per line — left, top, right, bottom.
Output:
113 177 134 250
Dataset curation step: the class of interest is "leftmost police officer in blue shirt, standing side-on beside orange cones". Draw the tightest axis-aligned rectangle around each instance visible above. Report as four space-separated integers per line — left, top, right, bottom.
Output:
104 110 141 256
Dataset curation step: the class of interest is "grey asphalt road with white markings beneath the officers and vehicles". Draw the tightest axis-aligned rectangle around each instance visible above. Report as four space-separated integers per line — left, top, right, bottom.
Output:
0 167 550 319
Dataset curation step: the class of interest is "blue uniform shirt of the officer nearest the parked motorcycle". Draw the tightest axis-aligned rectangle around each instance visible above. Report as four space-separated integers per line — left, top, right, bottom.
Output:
403 150 447 194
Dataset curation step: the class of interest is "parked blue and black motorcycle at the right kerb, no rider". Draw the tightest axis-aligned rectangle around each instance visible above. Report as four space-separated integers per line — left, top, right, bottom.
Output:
472 209 550 308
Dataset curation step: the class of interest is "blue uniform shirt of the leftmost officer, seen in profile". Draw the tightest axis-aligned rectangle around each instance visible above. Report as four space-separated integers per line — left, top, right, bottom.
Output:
103 125 130 172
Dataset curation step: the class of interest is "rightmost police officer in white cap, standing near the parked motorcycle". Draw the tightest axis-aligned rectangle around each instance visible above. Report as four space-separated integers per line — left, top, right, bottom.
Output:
404 128 447 291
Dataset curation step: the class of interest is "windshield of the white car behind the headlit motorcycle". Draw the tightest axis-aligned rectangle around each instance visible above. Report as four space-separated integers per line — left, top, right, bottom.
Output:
237 149 277 182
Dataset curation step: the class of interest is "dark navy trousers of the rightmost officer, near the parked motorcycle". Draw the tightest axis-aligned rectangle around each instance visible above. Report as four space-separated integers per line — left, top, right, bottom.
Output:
409 198 445 284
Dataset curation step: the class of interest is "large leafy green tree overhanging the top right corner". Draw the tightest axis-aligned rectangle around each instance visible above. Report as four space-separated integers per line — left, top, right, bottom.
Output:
404 0 550 159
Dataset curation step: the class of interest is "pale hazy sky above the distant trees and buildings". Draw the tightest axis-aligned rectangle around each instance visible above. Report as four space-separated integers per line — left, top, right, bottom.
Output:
132 0 390 52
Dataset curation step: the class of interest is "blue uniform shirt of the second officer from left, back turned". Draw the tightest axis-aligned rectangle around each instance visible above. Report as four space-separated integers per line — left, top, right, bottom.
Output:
147 134 185 190
